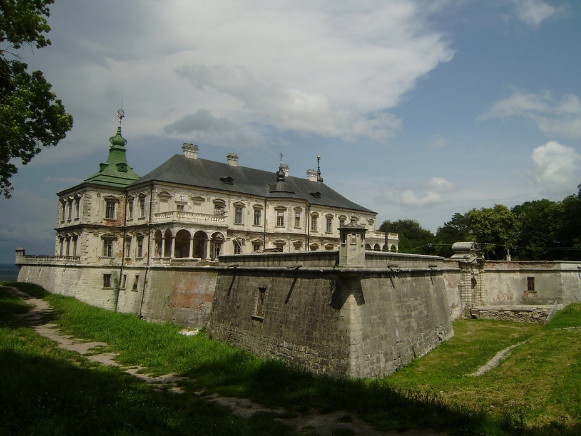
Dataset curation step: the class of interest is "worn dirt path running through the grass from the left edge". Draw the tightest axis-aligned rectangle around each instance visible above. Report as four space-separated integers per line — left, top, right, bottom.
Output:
8 288 438 436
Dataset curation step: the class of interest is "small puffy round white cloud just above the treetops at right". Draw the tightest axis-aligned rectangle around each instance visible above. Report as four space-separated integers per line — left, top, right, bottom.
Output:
531 141 579 192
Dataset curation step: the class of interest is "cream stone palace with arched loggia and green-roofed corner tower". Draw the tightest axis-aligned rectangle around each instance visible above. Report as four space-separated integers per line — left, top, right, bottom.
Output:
55 117 398 280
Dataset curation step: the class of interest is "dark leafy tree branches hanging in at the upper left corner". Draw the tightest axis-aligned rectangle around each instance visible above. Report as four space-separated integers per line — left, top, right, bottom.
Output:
0 0 73 198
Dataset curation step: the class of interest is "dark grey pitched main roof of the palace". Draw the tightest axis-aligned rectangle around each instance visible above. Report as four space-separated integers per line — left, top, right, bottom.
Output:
130 154 374 213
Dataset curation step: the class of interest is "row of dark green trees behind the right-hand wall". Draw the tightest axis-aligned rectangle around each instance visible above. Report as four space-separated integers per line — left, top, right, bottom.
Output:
380 195 581 260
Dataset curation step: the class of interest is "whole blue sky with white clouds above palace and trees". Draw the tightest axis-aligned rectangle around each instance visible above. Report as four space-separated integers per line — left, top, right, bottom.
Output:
0 0 581 263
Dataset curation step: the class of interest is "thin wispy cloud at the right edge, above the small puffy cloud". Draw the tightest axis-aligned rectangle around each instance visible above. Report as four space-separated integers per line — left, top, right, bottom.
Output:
479 90 581 138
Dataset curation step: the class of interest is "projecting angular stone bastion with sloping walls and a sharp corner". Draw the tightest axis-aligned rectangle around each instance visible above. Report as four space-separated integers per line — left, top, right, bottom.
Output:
209 252 453 377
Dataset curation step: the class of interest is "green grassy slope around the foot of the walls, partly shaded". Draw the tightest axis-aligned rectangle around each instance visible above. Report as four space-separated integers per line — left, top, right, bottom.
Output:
0 284 581 435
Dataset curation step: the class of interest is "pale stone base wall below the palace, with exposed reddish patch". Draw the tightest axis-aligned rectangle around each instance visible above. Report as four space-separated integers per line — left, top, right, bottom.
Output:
18 256 218 328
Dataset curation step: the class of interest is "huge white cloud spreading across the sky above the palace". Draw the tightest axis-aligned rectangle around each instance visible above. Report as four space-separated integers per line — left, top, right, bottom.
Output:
23 0 453 160
